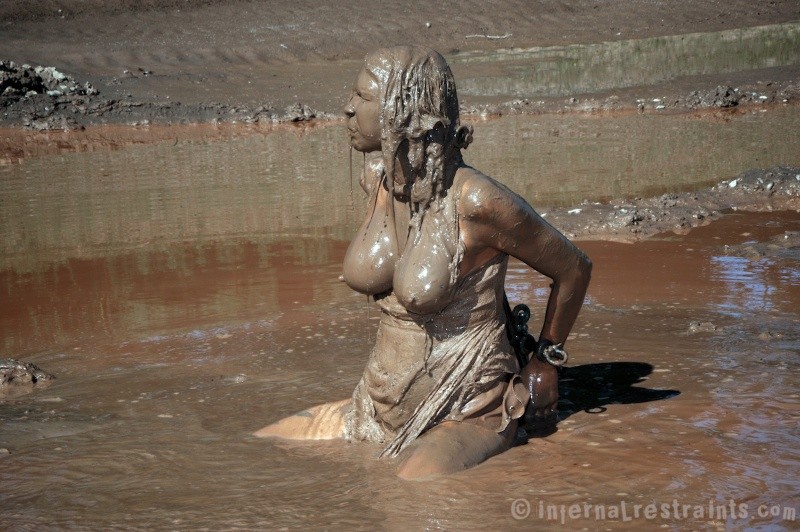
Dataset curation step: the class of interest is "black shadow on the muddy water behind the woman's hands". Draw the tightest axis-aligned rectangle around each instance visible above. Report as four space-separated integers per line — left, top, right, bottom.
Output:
525 362 681 438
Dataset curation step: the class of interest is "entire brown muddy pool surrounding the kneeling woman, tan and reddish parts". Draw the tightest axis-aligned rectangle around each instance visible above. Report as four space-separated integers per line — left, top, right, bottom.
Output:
0 107 800 530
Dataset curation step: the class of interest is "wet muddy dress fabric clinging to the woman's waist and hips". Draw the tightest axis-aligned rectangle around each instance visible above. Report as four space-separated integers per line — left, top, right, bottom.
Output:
345 251 519 450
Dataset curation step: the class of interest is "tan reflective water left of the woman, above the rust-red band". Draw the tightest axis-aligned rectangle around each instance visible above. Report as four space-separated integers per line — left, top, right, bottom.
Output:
0 121 357 270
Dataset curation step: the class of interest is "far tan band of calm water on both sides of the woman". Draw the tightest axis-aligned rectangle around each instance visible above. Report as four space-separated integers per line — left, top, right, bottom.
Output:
0 107 800 272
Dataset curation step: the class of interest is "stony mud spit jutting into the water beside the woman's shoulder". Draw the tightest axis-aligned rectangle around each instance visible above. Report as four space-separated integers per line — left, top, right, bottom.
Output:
542 167 800 241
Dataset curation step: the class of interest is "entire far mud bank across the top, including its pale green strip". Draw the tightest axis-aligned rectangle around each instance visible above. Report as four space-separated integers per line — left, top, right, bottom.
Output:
0 0 800 129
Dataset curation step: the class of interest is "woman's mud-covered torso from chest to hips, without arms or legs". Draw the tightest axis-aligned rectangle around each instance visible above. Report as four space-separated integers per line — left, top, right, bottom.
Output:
344 162 522 456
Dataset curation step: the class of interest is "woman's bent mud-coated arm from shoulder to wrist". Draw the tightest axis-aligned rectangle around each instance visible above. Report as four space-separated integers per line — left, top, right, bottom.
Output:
459 168 592 344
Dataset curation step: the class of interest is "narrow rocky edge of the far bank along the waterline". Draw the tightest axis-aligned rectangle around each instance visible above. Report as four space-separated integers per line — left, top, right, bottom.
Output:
0 56 800 131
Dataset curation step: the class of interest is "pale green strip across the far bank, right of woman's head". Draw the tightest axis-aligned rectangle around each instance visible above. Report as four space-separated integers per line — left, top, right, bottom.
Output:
449 23 800 98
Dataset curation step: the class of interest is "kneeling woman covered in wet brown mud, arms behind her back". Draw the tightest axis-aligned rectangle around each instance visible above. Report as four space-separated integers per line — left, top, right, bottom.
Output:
256 46 591 479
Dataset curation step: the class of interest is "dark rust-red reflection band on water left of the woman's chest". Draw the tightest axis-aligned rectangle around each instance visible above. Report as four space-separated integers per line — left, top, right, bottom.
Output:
0 238 350 356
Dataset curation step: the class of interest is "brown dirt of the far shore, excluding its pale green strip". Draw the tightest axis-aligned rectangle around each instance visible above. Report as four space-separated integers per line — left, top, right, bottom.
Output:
0 0 800 129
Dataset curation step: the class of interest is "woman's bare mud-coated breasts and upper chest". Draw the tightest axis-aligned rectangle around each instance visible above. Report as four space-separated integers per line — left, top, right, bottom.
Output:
343 160 462 315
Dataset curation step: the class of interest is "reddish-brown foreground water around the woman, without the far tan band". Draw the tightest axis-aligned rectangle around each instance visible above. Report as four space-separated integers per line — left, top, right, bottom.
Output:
0 212 800 529
